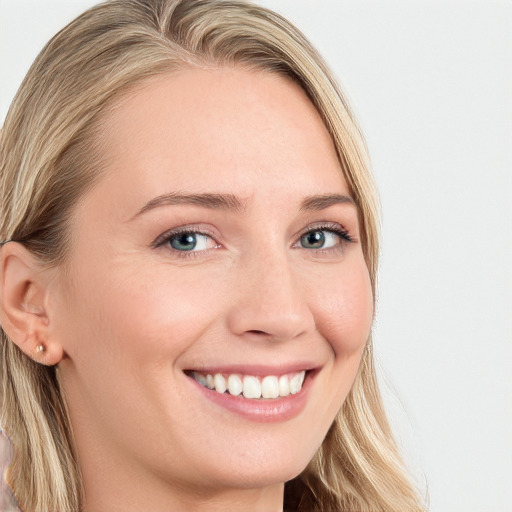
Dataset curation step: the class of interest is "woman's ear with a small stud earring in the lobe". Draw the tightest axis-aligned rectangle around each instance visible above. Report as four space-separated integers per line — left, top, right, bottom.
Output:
0 242 64 366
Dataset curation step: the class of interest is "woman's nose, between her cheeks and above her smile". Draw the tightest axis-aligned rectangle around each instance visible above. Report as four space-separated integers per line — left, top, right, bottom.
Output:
227 251 315 341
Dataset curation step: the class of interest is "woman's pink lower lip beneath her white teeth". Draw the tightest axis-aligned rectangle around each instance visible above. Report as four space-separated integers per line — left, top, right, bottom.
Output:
187 372 313 423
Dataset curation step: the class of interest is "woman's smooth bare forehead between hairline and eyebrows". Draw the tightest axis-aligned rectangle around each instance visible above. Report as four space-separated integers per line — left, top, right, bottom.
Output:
96 67 348 204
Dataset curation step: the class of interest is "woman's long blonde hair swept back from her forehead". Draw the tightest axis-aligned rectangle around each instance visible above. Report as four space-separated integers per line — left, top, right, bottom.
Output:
0 0 424 512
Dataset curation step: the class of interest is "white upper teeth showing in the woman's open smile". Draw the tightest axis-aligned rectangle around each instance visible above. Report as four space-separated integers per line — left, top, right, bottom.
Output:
187 370 306 400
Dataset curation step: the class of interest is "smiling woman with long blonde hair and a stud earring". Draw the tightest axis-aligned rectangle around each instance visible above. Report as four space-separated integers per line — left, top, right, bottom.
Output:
0 0 423 512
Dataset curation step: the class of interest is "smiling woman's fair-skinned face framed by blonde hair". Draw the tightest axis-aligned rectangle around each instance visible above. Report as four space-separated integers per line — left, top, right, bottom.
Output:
54 68 372 510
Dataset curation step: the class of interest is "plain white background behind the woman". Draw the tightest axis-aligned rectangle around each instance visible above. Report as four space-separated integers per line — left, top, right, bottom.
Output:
0 0 512 512
